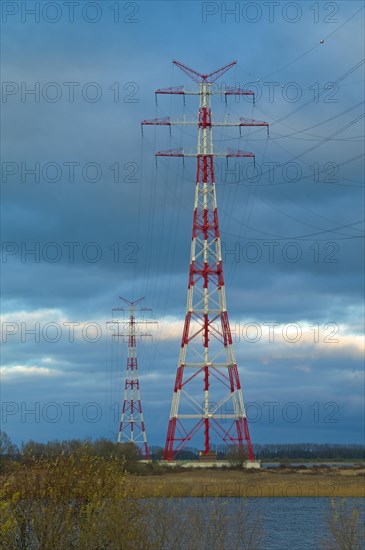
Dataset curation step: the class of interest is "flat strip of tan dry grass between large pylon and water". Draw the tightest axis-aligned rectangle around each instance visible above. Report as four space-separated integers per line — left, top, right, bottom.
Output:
133 468 365 498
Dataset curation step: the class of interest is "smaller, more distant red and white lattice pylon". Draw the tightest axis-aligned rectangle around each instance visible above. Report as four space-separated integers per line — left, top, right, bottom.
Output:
109 296 157 460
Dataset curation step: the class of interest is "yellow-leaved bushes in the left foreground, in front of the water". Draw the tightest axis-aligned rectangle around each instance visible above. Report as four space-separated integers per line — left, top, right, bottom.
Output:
0 451 263 550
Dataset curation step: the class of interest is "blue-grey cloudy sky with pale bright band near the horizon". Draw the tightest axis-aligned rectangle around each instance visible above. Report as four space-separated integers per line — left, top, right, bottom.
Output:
1 0 364 447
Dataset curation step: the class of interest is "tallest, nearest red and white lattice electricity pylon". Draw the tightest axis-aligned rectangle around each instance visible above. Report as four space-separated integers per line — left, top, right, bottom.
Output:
142 61 268 461
